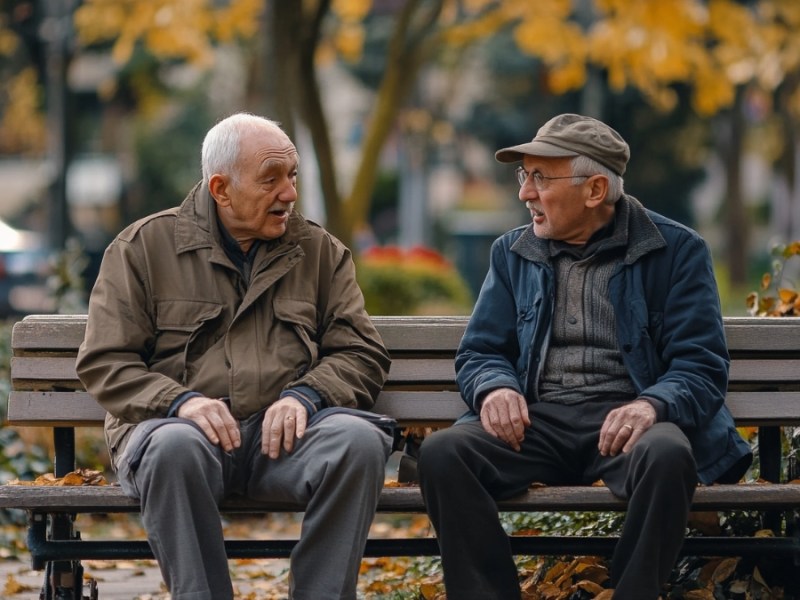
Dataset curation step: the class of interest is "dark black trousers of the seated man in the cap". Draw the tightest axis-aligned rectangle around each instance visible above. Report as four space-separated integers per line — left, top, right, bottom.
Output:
418 402 697 600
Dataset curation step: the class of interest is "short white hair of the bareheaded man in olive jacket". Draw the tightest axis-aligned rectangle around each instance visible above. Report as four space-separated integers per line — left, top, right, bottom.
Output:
201 112 283 186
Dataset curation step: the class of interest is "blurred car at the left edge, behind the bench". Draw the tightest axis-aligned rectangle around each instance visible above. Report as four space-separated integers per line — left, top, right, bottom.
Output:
0 221 54 318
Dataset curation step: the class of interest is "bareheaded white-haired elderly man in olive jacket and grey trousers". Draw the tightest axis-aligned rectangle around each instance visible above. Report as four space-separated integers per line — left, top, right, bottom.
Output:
78 114 391 600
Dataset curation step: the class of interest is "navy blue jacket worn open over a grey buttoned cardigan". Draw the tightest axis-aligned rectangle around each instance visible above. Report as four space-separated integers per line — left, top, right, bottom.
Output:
456 196 752 484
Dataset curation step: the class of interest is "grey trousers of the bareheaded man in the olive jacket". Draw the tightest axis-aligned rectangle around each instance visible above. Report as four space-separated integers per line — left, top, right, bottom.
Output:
117 412 391 600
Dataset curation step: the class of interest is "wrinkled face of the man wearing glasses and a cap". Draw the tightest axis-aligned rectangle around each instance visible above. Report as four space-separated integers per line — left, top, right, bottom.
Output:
519 156 598 244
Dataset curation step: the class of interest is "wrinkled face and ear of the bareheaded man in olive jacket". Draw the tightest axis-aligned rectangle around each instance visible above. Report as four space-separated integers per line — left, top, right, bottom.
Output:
209 126 298 252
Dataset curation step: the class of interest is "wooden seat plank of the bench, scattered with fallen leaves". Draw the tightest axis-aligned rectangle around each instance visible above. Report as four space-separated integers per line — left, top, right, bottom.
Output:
0 483 800 513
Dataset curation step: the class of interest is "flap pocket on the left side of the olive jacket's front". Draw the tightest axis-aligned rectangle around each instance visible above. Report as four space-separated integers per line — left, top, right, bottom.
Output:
152 299 223 382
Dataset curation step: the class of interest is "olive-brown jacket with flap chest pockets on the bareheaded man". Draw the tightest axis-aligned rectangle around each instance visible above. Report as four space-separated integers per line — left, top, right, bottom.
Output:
77 184 390 460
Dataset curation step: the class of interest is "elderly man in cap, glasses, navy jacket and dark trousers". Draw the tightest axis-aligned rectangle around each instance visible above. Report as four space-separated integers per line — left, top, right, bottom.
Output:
418 114 751 600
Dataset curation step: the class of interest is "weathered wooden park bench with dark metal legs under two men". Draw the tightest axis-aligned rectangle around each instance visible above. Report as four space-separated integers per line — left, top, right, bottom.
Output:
0 316 800 599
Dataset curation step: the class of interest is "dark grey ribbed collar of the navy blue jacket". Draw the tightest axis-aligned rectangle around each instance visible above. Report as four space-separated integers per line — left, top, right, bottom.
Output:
511 194 667 264
